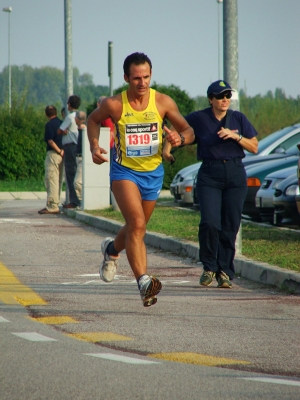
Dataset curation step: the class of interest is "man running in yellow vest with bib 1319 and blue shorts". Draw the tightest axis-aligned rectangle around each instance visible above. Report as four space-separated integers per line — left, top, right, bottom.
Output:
87 53 194 307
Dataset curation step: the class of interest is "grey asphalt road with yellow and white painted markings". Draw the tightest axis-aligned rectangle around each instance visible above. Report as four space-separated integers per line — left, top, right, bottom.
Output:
0 200 300 400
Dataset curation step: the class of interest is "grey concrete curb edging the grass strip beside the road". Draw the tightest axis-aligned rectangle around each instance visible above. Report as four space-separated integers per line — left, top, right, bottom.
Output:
63 209 300 294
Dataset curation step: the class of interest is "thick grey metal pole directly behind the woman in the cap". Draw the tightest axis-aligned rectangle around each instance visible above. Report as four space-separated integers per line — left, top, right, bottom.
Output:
223 0 242 254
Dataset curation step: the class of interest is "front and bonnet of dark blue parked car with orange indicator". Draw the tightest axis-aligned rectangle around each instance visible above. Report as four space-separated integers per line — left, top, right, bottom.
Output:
243 156 299 221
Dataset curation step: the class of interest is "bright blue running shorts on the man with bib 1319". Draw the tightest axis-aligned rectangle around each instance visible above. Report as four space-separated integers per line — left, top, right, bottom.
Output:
110 161 164 201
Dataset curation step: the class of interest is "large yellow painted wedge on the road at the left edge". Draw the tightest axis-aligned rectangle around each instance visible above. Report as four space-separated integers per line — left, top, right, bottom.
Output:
0 262 47 307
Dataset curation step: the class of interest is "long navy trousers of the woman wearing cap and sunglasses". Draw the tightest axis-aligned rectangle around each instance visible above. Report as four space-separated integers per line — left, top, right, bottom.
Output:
196 158 247 279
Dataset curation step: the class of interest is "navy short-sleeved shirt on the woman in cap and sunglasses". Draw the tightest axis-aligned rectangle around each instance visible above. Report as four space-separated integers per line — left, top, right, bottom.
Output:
185 107 258 160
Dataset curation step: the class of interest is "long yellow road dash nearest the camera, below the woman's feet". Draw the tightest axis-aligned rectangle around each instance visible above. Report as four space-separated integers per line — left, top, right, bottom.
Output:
148 353 250 367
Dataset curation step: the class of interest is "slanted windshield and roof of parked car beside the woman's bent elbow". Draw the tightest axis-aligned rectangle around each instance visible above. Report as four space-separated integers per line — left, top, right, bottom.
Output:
245 123 300 157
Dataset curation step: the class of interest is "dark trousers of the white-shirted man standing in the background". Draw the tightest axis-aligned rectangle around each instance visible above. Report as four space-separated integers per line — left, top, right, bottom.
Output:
63 143 80 206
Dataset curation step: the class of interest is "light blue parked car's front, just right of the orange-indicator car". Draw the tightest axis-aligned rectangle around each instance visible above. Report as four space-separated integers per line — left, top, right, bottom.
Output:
255 166 296 223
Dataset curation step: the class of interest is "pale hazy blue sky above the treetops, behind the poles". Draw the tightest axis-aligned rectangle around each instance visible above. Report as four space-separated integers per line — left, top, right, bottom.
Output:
0 0 300 98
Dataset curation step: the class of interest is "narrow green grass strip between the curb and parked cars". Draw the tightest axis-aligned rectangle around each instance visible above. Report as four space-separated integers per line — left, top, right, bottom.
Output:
87 202 300 272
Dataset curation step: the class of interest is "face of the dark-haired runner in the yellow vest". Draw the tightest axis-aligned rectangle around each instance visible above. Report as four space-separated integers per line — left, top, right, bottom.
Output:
124 62 151 96
